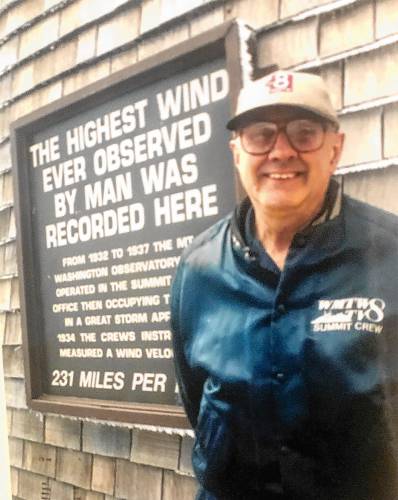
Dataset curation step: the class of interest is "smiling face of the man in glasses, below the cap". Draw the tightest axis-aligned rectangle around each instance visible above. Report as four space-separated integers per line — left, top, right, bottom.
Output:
231 106 344 214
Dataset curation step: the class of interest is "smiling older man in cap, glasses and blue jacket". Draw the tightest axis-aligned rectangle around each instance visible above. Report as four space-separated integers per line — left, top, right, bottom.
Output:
172 71 398 500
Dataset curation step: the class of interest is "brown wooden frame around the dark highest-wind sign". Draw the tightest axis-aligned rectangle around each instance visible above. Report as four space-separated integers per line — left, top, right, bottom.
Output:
11 21 250 427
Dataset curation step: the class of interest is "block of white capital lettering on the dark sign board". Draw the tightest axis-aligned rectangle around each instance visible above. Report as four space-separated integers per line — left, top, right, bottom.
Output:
28 62 233 404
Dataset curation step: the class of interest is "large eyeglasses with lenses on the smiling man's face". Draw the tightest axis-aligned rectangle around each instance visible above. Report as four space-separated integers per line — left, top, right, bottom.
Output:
239 119 328 155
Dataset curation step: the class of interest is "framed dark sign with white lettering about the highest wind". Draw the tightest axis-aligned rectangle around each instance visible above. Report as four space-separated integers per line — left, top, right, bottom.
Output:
13 20 252 425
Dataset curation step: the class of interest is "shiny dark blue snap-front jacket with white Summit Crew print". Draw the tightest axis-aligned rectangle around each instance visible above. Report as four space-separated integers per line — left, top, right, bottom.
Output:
172 193 398 500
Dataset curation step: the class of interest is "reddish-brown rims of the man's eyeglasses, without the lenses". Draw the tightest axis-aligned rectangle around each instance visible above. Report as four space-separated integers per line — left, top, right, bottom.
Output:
238 118 338 156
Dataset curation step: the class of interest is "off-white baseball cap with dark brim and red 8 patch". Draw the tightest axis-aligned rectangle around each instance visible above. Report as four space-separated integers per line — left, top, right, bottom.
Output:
227 70 339 130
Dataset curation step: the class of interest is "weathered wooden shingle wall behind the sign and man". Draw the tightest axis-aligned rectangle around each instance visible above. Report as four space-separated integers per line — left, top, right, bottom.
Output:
0 0 398 500
